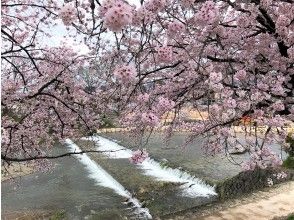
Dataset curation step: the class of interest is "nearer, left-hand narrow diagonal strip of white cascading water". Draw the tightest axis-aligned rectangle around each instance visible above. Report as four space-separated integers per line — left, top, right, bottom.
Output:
65 139 152 219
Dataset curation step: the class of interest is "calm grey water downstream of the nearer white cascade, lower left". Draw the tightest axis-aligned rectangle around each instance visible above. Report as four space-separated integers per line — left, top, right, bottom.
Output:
1 144 131 219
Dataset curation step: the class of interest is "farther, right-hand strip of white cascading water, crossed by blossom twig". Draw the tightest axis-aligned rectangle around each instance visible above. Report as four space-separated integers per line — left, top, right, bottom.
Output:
83 136 217 198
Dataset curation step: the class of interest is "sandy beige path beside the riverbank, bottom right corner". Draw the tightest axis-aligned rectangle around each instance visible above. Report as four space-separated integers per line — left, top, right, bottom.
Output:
173 181 294 220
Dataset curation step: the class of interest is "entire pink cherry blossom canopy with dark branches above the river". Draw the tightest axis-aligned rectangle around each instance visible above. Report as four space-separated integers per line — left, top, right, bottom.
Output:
1 0 294 169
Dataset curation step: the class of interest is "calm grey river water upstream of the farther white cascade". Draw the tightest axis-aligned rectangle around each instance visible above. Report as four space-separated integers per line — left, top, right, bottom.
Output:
103 132 285 182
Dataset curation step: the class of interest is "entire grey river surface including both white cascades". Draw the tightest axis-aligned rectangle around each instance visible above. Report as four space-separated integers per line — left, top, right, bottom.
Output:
1 133 279 220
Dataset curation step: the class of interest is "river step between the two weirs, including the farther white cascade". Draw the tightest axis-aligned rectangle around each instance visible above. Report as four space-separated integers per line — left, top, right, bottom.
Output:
77 137 216 216
